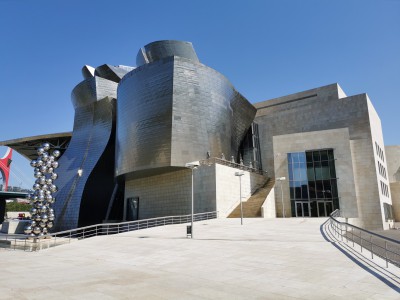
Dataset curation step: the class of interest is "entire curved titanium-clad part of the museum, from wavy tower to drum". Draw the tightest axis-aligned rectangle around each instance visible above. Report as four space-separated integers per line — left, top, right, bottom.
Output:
48 41 256 230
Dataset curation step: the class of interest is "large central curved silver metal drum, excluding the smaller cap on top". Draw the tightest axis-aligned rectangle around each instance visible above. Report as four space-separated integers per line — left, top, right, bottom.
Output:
116 55 256 177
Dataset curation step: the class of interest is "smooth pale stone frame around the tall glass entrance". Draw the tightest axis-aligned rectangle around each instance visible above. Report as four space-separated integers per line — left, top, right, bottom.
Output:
273 128 358 218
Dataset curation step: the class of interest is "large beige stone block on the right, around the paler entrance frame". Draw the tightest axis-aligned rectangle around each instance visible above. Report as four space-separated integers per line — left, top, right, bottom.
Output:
254 84 390 229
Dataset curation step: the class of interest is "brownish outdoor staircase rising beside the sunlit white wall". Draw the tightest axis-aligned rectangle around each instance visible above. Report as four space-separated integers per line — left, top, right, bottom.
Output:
228 178 275 218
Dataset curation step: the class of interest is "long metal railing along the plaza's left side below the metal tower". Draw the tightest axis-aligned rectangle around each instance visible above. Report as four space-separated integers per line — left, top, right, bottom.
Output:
0 211 218 251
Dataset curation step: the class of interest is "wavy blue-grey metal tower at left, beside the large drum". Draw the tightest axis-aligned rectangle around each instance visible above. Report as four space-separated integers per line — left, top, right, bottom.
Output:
54 77 117 230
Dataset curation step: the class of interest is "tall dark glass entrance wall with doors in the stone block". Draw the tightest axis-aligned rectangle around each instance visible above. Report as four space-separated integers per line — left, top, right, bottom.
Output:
288 149 339 217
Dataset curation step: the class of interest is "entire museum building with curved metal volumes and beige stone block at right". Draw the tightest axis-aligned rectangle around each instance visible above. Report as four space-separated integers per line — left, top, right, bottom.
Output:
0 41 400 230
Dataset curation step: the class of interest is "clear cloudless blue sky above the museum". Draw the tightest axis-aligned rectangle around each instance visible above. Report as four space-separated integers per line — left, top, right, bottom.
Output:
0 0 400 187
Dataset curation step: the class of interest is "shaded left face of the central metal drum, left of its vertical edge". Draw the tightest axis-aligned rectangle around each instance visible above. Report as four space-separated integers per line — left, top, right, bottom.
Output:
116 59 173 175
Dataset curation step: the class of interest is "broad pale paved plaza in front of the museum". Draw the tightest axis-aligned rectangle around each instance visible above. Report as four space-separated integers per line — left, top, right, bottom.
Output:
0 218 400 300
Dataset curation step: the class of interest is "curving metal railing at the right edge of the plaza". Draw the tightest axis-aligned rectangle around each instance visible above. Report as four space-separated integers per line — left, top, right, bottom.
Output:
329 209 400 267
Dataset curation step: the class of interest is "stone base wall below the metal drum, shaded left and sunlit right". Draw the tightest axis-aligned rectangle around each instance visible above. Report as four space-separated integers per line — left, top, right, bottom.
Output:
125 164 267 219
